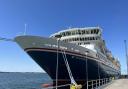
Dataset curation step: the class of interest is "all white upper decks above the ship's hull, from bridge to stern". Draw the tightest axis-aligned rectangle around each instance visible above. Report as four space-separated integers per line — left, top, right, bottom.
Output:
50 27 120 70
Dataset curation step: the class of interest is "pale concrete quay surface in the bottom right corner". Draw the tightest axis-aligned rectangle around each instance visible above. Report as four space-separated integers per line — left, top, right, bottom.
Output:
102 79 128 89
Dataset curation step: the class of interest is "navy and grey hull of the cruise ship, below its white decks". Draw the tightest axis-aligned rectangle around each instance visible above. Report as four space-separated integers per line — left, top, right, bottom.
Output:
15 36 120 89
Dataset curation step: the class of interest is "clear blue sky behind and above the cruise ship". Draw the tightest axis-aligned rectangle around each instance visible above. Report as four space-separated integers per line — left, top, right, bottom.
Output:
0 0 128 73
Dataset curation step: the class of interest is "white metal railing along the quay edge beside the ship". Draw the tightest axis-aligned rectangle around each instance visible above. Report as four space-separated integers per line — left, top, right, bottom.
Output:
87 78 114 89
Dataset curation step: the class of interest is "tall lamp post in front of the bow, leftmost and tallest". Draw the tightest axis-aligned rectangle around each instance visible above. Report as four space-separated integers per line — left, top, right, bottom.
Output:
55 35 62 89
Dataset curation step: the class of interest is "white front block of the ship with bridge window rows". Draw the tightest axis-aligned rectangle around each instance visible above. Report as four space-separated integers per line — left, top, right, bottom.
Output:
50 27 102 51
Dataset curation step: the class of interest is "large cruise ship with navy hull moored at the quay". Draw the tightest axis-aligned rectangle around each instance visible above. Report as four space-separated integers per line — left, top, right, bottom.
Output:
15 27 121 89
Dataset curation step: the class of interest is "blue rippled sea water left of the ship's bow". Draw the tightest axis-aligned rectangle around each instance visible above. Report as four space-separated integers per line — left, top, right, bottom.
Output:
0 73 52 89
